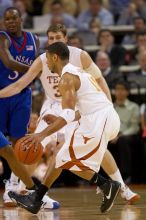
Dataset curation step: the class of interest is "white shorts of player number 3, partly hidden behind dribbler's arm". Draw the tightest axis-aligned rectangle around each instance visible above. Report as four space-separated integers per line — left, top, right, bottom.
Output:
35 100 64 148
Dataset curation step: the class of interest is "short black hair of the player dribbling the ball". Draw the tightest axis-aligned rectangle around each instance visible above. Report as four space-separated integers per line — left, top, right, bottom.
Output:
47 42 69 60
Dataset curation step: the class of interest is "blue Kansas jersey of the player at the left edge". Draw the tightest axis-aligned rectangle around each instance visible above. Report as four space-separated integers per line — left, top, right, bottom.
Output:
0 31 37 89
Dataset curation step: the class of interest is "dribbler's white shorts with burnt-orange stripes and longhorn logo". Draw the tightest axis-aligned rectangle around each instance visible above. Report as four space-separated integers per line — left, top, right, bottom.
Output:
56 106 120 172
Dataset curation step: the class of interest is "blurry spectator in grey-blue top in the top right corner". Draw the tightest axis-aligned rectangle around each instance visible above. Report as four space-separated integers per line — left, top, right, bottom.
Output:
117 2 138 25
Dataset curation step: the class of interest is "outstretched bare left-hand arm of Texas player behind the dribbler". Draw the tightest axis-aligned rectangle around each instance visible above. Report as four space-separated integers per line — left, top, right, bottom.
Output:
0 57 42 98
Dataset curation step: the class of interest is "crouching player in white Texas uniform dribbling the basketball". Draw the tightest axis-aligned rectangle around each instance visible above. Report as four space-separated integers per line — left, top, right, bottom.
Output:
8 42 121 214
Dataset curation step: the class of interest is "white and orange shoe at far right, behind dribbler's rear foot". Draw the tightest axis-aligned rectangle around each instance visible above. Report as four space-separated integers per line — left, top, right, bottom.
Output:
120 185 140 205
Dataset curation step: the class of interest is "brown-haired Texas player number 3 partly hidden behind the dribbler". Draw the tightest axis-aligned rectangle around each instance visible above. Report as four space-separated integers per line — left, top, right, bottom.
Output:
0 24 140 204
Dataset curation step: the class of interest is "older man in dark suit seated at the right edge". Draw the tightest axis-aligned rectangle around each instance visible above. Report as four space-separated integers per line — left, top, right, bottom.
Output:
127 50 146 88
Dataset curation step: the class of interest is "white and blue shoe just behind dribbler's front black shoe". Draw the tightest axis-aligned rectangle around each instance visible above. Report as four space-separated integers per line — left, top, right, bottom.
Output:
41 195 60 209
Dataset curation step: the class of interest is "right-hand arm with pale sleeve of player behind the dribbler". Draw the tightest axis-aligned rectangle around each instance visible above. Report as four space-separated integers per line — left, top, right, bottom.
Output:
81 51 112 101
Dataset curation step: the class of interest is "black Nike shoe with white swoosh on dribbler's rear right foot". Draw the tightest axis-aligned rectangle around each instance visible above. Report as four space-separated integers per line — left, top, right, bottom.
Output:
100 180 121 212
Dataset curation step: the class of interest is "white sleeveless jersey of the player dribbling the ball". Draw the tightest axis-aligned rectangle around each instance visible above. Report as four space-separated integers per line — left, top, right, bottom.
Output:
62 63 112 115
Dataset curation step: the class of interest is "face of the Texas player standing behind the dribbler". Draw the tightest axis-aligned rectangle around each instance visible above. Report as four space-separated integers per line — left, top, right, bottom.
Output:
48 31 67 45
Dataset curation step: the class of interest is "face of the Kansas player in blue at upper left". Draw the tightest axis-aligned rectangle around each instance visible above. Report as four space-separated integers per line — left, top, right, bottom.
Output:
4 10 21 34
